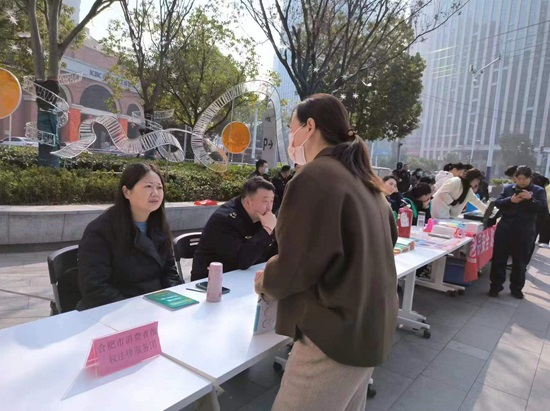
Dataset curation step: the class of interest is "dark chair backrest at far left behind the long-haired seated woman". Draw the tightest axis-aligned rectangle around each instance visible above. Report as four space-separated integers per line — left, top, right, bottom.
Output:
48 245 82 313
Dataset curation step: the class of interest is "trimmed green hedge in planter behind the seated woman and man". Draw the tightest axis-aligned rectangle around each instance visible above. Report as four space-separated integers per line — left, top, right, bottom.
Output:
0 146 253 205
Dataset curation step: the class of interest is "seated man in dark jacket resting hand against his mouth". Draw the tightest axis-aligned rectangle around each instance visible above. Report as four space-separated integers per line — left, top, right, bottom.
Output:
191 177 277 281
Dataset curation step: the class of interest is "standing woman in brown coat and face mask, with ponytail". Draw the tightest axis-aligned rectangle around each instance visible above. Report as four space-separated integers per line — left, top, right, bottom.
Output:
255 94 398 411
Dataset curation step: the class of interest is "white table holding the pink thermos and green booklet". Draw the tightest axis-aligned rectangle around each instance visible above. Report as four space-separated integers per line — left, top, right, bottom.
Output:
82 264 290 385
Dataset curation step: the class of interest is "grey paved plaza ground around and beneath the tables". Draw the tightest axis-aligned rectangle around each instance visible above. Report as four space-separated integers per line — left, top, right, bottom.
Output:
0 249 550 411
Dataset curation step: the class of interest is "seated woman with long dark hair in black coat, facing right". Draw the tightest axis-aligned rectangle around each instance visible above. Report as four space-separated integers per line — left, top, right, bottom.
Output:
77 163 181 310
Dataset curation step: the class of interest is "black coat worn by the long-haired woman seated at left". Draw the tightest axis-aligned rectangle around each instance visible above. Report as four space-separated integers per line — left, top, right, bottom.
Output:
76 210 181 310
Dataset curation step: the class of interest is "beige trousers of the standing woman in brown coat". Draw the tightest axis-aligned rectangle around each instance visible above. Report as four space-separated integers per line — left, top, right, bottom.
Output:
272 336 374 411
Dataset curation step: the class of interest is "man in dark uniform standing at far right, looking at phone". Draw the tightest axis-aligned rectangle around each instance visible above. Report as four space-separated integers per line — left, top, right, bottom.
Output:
489 166 548 299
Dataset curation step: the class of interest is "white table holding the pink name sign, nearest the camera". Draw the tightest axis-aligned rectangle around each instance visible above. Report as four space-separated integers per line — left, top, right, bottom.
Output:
0 311 213 411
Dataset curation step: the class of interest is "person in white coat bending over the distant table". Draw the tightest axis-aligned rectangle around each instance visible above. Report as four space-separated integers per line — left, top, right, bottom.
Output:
432 168 487 218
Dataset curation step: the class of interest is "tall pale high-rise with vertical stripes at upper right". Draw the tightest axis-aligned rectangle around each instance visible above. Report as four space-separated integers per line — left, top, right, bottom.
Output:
405 0 550 175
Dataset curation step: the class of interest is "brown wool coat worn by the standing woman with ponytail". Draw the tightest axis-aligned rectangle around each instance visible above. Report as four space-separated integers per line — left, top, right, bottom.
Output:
262 148 398 367
